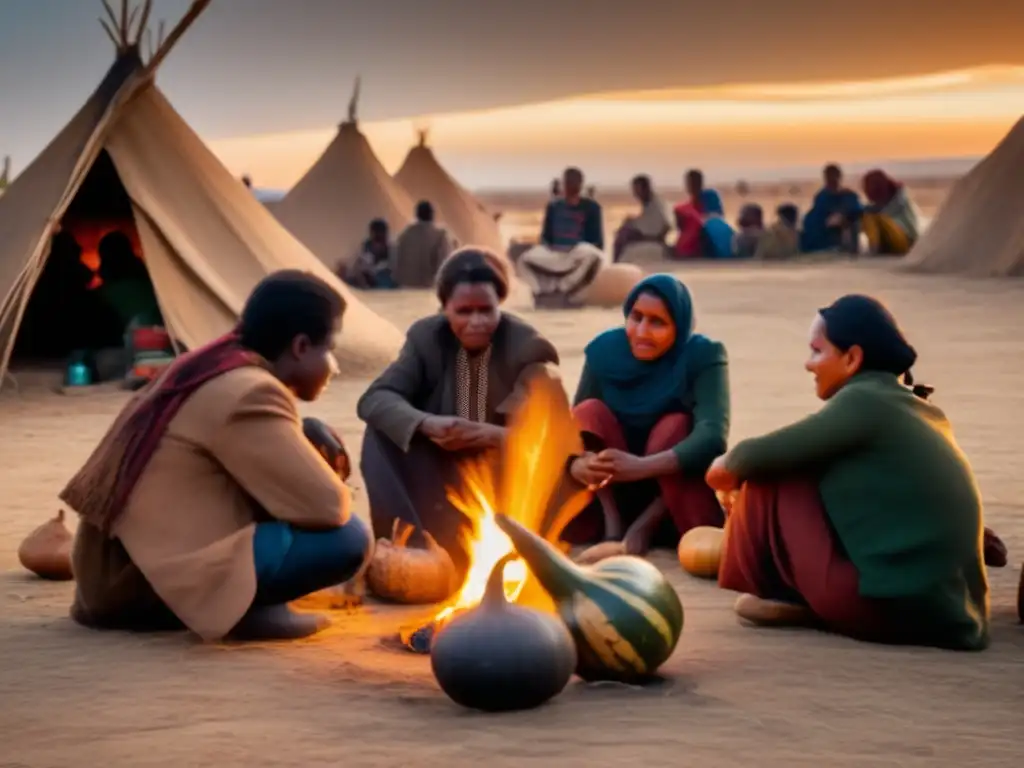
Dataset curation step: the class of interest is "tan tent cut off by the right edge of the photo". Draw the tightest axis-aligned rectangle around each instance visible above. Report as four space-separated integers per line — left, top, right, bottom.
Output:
907 118 1024 276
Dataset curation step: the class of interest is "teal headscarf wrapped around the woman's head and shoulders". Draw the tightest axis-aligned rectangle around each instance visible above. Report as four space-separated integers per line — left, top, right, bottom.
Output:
584 274 714 429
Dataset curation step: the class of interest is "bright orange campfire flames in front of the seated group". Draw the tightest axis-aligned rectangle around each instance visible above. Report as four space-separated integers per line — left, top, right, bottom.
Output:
399 376 587 653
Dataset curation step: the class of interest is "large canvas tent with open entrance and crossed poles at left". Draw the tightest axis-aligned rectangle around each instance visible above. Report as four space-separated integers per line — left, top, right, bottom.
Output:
0 0 401 387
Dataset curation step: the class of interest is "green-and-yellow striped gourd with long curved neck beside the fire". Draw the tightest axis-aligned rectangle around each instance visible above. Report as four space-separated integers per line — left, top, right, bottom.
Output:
497 515 683 682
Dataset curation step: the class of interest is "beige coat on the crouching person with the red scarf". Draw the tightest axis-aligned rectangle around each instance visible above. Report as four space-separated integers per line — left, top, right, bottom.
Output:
75 367 350 640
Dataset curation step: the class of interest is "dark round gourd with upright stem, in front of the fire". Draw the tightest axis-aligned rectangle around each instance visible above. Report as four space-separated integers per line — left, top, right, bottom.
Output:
430 555 577 712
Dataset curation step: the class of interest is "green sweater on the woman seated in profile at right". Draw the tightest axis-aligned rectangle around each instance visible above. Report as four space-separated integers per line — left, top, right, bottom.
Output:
727 372 988 648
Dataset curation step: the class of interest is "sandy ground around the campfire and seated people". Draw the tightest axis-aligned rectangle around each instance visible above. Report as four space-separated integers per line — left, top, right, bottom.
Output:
0 266 1024 768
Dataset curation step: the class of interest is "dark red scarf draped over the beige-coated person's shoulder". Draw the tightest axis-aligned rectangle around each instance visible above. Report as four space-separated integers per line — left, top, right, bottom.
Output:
60 333 266 532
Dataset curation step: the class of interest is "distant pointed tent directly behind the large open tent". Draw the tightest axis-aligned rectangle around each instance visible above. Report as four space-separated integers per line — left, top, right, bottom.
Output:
271 78 415 269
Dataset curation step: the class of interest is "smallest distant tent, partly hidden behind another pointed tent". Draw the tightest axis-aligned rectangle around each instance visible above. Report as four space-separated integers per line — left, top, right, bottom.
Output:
394 131 506 255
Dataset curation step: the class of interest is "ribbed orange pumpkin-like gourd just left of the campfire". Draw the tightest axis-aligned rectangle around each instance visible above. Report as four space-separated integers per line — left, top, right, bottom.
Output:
367 519 459 605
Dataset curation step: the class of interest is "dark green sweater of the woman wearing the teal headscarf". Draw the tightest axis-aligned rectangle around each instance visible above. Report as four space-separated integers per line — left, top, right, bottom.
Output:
573 342 729 477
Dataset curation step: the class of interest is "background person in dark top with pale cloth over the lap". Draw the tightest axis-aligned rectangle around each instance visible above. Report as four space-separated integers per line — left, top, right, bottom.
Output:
518 168 604 308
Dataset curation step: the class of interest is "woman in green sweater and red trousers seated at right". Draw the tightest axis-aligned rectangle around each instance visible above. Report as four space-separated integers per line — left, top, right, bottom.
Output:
708 295 1006 649
